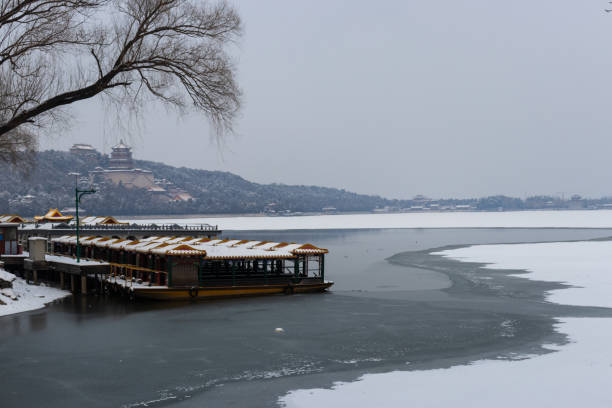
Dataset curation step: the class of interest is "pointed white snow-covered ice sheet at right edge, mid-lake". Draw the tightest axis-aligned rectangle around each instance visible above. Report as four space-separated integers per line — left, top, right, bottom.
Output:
437 241 612 307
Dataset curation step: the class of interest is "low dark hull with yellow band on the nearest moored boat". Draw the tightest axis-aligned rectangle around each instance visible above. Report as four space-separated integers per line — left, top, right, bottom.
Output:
133 282 334 300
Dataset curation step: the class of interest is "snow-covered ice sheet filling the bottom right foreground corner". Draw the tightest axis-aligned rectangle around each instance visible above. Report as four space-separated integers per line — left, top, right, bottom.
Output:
279 318 612 408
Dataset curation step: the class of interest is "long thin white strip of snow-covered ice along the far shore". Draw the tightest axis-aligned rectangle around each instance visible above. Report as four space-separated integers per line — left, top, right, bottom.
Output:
125 210 612 230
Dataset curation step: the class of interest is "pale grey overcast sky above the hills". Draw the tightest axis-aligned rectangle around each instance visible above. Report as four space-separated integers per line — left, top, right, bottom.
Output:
41 0 612 198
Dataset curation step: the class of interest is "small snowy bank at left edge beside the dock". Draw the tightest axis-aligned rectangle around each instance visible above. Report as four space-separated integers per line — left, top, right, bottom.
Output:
0 269 70 316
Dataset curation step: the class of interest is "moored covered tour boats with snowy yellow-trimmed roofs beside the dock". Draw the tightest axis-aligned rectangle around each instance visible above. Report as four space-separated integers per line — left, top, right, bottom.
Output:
51 235 333 300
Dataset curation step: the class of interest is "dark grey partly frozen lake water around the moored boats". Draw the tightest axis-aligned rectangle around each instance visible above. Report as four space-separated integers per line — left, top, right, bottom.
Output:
0 229 612 407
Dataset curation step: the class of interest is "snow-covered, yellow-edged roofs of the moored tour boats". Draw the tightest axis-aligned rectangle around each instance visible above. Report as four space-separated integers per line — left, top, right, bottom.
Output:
51 235 328 259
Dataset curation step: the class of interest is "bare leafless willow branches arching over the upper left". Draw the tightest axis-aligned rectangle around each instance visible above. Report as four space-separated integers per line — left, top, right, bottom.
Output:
0 0 241 163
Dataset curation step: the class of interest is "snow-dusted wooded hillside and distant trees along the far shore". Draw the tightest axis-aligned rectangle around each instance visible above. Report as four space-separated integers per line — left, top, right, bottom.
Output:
0 150 612 216
